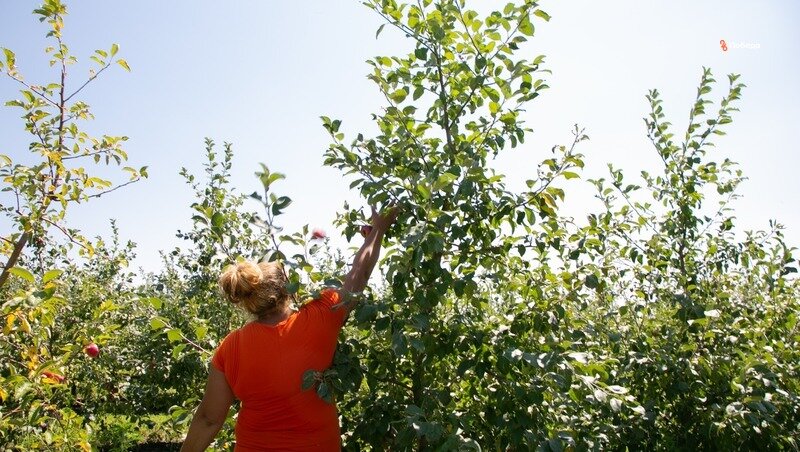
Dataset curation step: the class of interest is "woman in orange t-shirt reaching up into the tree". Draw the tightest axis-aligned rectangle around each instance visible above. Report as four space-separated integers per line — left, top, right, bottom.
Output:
181 208 397 452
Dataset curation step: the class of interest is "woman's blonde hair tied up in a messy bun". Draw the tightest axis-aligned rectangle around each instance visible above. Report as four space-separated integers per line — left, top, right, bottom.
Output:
219 261 289 317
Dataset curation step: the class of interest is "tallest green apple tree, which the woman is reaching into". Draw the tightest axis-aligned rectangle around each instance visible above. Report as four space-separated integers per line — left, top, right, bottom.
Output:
323 0 586 450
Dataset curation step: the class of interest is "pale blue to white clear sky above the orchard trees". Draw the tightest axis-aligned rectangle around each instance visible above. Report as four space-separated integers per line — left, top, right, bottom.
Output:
0 0 800 271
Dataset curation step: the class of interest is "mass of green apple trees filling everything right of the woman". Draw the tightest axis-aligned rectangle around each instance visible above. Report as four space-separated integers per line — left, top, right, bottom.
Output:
323 1 798 450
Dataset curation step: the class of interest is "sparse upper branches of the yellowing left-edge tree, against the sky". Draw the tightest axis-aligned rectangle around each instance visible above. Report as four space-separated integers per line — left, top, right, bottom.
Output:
0 0 147 272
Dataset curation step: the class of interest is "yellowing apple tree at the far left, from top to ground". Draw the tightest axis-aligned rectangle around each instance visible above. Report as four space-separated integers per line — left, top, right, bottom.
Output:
0 0 147 444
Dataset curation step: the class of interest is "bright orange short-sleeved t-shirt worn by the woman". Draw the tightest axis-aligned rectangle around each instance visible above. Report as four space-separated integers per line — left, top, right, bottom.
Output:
211 289 346 452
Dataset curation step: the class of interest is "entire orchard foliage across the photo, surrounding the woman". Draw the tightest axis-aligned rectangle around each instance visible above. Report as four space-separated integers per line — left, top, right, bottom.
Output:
0 0 800 451
